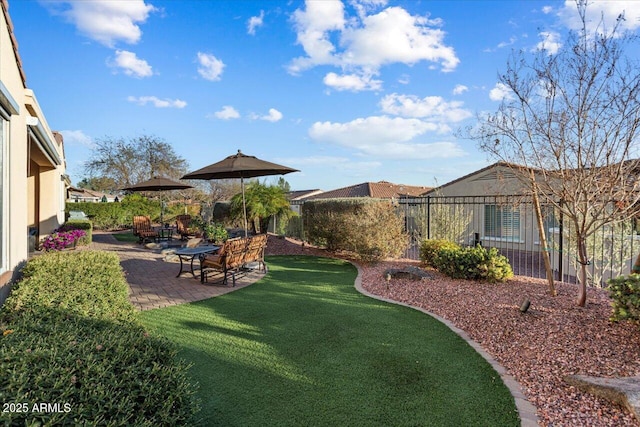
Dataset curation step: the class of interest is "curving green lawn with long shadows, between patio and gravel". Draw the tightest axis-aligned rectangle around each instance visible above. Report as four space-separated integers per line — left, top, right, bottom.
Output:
142 256 520 426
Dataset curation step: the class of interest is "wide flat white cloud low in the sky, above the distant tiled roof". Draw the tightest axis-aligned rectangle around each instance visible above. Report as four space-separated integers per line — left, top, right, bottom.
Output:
309 116 465 159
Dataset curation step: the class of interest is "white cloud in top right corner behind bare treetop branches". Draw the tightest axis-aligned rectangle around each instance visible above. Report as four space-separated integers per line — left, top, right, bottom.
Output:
558 0 640 31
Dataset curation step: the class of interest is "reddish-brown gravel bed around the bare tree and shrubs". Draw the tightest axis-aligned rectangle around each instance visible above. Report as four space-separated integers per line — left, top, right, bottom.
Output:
267 236 640 427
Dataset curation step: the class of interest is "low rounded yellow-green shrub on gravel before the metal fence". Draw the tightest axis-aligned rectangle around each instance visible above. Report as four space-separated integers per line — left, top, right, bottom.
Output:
433 246 513 283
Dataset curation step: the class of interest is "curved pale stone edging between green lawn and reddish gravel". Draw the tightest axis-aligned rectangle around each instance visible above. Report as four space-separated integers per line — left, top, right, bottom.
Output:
345 260 539 427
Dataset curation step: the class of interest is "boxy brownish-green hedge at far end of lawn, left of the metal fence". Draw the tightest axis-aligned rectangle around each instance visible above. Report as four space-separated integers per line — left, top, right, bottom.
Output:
303 198 408 261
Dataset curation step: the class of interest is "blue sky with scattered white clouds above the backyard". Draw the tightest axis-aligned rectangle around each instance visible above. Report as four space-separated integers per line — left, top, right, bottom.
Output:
9 0 640 190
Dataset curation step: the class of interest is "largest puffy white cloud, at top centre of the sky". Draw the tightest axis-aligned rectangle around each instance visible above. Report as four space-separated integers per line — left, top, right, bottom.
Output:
289 1 460 85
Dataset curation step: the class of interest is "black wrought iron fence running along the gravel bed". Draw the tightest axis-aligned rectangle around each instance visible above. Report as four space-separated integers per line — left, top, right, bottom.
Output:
398 196 640 286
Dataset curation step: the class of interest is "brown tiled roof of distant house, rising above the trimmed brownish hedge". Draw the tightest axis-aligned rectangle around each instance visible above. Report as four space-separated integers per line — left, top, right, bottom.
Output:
305 181 431 200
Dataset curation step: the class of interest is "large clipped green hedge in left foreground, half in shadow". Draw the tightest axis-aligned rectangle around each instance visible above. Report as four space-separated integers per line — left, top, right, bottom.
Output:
0 251 197 426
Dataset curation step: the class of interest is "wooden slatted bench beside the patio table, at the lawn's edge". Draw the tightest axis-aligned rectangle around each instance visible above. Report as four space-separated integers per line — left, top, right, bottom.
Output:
200 234 267 286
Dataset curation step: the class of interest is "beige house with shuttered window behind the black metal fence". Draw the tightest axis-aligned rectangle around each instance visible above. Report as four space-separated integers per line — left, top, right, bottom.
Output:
408 162 640 283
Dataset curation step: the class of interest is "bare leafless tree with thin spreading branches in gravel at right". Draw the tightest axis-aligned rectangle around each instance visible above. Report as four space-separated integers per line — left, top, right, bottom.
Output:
469 1 640 306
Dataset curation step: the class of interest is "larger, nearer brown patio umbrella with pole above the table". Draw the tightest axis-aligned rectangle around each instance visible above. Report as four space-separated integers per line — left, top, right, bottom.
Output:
181 150 299 237
